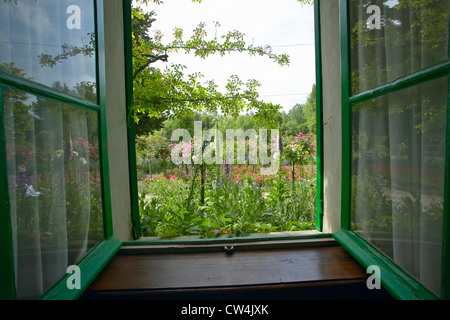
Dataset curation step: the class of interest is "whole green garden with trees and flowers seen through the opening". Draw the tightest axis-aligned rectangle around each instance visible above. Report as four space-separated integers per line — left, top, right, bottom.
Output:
129 0 316 238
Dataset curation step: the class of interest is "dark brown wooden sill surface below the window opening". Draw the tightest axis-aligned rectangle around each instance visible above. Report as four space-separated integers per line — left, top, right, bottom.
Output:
90 246 367 290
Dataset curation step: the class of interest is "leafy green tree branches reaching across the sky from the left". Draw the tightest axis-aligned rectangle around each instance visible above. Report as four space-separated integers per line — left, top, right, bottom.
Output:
132 0 289 132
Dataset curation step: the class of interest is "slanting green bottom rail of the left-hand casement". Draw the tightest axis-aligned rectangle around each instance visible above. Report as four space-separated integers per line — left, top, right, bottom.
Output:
41 237 122 300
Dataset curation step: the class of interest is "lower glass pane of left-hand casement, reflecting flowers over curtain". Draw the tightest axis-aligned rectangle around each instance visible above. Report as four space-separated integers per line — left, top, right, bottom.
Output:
3 90 103 299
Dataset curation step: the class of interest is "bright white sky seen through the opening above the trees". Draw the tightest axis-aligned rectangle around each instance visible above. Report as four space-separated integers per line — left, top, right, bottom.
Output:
147 0 315 111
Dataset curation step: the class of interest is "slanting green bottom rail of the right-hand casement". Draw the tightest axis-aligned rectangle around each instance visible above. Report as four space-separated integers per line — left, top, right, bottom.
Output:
333 229 437 300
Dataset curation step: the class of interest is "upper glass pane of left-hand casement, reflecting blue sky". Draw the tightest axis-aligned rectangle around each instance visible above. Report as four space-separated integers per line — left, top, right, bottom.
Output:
0 0 96 102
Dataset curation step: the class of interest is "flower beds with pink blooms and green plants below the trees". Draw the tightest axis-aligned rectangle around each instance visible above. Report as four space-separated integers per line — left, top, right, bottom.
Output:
137 126 316 238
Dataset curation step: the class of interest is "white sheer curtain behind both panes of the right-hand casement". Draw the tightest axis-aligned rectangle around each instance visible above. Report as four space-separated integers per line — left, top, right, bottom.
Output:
350 0 450 295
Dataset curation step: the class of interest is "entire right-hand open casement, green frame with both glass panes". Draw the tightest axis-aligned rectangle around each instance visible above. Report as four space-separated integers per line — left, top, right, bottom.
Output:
335 0 450 299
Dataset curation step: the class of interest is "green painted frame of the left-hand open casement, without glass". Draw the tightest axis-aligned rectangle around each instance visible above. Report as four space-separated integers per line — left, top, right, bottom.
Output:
0 0 122 300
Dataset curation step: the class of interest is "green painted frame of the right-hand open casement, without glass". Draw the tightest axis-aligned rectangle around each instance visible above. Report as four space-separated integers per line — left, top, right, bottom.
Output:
334 0 450 300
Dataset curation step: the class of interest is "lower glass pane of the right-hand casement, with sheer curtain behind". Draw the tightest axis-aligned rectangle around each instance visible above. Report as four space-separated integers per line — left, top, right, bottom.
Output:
352 78 448 295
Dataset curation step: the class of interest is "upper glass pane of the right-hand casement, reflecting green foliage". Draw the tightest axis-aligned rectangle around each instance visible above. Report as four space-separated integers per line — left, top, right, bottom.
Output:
349 0 450 94
